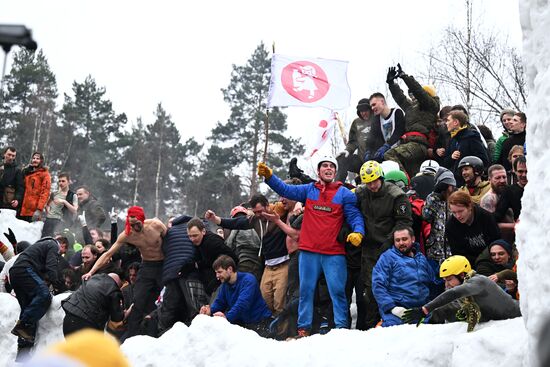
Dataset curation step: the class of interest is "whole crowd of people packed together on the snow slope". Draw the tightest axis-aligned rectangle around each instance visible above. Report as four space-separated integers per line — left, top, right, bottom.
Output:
0 65 528 362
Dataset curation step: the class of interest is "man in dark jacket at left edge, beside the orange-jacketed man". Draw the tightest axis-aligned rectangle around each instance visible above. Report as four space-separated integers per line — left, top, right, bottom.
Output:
0 147 25 210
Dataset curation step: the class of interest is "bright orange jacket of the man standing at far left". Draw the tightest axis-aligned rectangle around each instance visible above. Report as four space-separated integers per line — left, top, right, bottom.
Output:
20 167 52 217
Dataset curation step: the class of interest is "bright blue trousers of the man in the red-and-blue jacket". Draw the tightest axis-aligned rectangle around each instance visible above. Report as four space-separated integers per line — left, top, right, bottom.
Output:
298 251 348 330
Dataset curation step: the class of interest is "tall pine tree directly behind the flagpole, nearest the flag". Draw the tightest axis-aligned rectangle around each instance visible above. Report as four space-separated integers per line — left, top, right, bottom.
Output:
209 43 304 195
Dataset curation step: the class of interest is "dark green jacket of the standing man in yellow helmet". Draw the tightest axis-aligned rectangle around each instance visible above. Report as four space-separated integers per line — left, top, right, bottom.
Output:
355 181 412 245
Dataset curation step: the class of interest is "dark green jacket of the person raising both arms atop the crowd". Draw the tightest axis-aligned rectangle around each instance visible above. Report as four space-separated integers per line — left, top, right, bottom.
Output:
389 75 439 142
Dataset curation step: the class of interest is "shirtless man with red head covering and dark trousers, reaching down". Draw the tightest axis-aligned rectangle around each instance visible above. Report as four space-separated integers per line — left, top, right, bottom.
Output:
82 206 166 338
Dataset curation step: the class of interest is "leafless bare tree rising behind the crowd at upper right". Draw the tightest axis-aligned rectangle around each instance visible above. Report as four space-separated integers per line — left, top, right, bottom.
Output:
426 0 527 129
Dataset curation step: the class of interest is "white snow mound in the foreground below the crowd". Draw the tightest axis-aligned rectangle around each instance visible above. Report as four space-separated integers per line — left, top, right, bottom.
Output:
122 316 526 367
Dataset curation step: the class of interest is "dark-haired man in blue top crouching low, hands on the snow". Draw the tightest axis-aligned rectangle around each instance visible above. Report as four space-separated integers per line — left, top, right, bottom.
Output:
200 255 272 336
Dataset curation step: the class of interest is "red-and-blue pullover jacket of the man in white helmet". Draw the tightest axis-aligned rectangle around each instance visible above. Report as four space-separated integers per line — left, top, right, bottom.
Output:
266 175 365 255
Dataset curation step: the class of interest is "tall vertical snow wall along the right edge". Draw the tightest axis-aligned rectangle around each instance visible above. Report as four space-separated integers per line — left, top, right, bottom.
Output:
517 0 550 365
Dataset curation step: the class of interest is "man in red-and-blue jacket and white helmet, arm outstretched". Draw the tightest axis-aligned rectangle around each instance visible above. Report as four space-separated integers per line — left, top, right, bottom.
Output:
258 157 365 337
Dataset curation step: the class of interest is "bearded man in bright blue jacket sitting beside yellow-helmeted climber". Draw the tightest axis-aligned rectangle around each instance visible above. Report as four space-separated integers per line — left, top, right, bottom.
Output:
372 226 436 326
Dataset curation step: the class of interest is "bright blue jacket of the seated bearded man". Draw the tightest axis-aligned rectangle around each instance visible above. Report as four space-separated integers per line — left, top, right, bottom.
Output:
372 243 436 313
